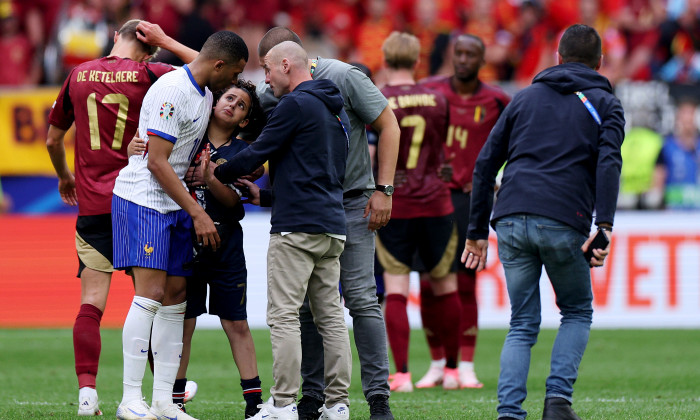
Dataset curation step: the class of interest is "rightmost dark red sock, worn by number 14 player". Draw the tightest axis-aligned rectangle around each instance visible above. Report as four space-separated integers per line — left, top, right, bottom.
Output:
457 271 479 362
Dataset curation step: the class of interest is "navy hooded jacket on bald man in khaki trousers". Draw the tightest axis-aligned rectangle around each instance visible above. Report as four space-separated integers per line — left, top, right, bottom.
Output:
214 80 350 235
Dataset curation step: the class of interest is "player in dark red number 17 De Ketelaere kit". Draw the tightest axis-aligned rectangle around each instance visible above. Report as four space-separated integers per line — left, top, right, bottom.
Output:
46 20 197 415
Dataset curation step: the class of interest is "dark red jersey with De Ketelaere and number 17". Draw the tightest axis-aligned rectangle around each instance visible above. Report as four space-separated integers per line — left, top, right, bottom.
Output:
49 57 173 216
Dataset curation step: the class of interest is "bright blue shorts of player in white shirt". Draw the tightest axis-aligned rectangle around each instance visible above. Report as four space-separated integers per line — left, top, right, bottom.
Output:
112 195 193 276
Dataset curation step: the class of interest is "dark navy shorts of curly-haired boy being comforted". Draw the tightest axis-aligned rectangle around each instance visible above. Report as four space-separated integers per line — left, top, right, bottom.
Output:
185 223 248 321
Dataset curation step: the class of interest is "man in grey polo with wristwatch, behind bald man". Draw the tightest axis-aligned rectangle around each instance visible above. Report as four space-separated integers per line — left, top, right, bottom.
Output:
258 27 399 420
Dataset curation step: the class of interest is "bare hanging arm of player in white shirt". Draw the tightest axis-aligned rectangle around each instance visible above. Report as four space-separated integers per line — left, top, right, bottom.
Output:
148 134 221 250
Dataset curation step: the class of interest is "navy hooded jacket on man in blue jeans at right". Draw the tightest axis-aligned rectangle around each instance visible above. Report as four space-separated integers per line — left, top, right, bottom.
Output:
467 63 625 239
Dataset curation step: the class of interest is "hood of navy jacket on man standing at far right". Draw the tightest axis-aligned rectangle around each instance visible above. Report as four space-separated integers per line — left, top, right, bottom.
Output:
532 63 613 95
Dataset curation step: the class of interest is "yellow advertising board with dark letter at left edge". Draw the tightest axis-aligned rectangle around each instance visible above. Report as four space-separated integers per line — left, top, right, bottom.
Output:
0 87 74 175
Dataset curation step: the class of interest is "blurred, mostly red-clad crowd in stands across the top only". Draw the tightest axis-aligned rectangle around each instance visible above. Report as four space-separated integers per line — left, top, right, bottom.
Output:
0 0 700 87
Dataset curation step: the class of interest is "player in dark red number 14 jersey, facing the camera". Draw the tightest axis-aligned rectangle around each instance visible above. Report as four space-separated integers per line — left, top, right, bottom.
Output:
416 34 510 388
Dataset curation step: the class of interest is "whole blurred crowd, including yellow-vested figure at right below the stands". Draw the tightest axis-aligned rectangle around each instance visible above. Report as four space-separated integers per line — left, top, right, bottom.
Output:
0 0 700 209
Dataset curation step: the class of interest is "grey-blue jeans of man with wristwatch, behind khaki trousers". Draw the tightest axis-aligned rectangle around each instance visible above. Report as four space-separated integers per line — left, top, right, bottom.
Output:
299 195 389 401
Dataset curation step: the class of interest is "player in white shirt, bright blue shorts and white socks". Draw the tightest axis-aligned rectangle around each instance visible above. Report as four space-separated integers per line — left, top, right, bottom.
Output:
112 31 248 420
